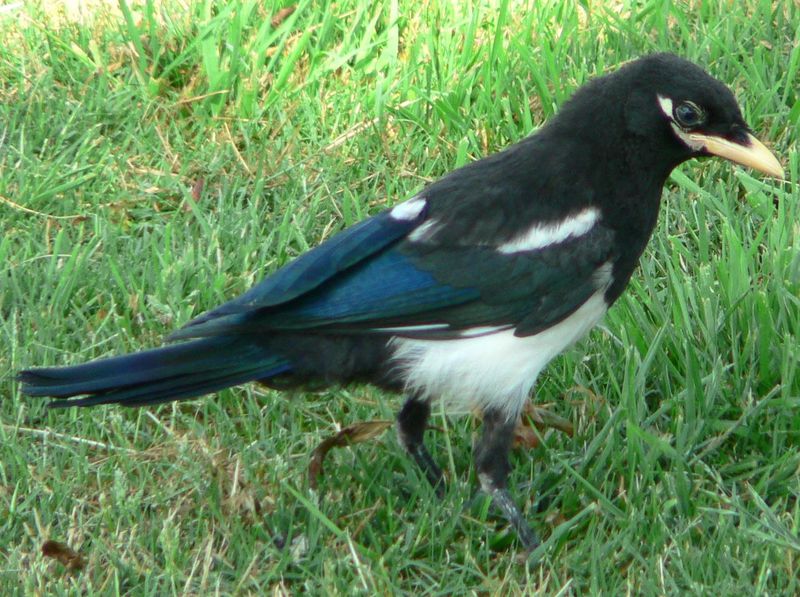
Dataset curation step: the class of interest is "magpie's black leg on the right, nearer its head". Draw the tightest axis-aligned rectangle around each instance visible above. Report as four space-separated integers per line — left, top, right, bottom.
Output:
475 410 539 551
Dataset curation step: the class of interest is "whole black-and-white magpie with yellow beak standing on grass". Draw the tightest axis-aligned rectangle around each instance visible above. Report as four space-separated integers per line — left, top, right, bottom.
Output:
18 53 783 552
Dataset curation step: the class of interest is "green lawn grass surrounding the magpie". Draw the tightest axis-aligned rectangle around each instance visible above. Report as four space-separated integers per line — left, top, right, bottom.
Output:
0 0 800 595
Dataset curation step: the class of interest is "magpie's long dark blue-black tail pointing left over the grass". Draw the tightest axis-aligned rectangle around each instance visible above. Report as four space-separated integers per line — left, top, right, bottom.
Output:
18 337 290 408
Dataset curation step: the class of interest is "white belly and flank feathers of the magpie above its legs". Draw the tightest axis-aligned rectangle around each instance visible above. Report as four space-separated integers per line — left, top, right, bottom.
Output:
392 290 608 419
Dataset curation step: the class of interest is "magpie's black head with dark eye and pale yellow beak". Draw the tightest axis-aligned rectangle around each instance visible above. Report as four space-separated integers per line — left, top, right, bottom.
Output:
612 54 784 178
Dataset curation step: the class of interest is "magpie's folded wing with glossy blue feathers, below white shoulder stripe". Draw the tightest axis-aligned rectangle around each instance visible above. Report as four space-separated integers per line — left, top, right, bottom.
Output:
173 200 614 339
